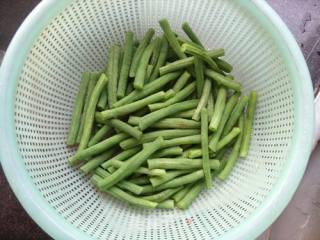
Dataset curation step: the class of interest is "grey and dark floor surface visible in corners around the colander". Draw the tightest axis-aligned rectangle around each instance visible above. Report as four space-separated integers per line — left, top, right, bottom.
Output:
0 0 320 240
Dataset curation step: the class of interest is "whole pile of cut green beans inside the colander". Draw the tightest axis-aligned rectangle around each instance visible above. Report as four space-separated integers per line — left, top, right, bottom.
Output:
66 19 257 209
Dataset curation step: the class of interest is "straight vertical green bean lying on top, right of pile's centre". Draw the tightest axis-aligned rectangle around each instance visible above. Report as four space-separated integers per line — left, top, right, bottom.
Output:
201 108 212 188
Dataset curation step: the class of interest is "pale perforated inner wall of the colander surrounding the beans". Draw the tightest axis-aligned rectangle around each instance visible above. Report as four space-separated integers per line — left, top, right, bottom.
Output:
11 0 300 239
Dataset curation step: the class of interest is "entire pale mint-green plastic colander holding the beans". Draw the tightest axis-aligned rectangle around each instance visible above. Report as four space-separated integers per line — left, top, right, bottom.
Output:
0 0 314 240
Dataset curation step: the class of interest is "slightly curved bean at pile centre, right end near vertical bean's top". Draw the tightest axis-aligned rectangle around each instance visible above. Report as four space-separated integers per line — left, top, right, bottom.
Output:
139 100 198 131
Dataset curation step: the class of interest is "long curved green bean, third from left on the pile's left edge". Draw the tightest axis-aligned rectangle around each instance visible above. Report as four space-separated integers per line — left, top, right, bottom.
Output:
78 73 108 151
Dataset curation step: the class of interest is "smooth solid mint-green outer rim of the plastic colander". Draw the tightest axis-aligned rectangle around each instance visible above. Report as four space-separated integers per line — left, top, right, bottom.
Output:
0 0 314 239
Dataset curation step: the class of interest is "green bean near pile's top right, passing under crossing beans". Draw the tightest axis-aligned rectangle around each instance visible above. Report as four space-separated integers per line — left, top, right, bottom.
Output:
159 48 224 76
